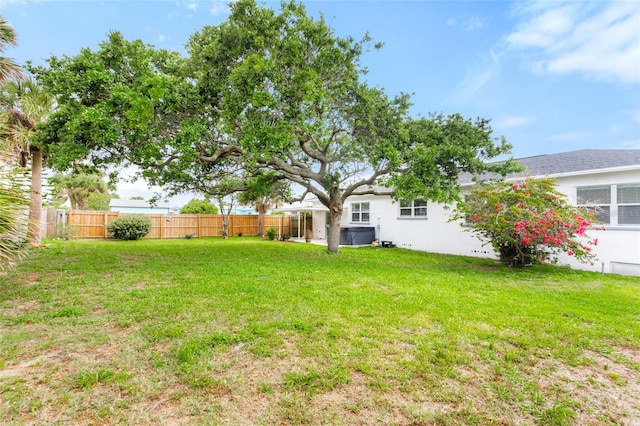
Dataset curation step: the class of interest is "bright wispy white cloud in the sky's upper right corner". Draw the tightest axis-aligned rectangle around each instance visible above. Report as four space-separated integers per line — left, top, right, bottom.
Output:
506 1 640 84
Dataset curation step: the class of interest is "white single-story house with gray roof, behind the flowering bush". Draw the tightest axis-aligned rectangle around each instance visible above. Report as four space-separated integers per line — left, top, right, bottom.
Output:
304 149 640 276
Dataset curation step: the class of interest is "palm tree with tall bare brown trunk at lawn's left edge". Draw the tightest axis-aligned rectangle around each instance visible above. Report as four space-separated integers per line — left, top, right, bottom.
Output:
0 78 54 246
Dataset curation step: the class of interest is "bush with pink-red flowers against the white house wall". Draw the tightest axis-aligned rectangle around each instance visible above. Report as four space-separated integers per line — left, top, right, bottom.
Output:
454 179 598 267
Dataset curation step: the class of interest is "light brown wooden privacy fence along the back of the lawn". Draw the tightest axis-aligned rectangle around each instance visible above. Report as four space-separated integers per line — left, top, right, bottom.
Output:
57 210 291 239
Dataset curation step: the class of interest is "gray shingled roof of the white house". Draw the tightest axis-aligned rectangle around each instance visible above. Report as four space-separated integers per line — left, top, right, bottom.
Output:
460 149 640 184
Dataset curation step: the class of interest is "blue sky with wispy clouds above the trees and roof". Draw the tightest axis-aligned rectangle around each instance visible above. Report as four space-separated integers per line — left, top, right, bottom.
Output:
0 0 640 201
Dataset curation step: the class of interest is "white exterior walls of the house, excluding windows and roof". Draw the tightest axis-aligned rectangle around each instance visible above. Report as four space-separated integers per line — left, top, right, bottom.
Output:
313 170 640 276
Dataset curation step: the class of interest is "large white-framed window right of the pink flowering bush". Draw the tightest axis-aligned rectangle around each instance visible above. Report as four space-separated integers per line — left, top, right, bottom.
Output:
576 183 640 226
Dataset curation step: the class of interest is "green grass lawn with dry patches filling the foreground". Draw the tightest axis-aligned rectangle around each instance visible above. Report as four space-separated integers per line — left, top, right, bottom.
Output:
0 238 640 425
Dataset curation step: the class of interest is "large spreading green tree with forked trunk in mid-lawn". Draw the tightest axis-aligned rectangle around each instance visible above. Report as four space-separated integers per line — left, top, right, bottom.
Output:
32 0 511 252
